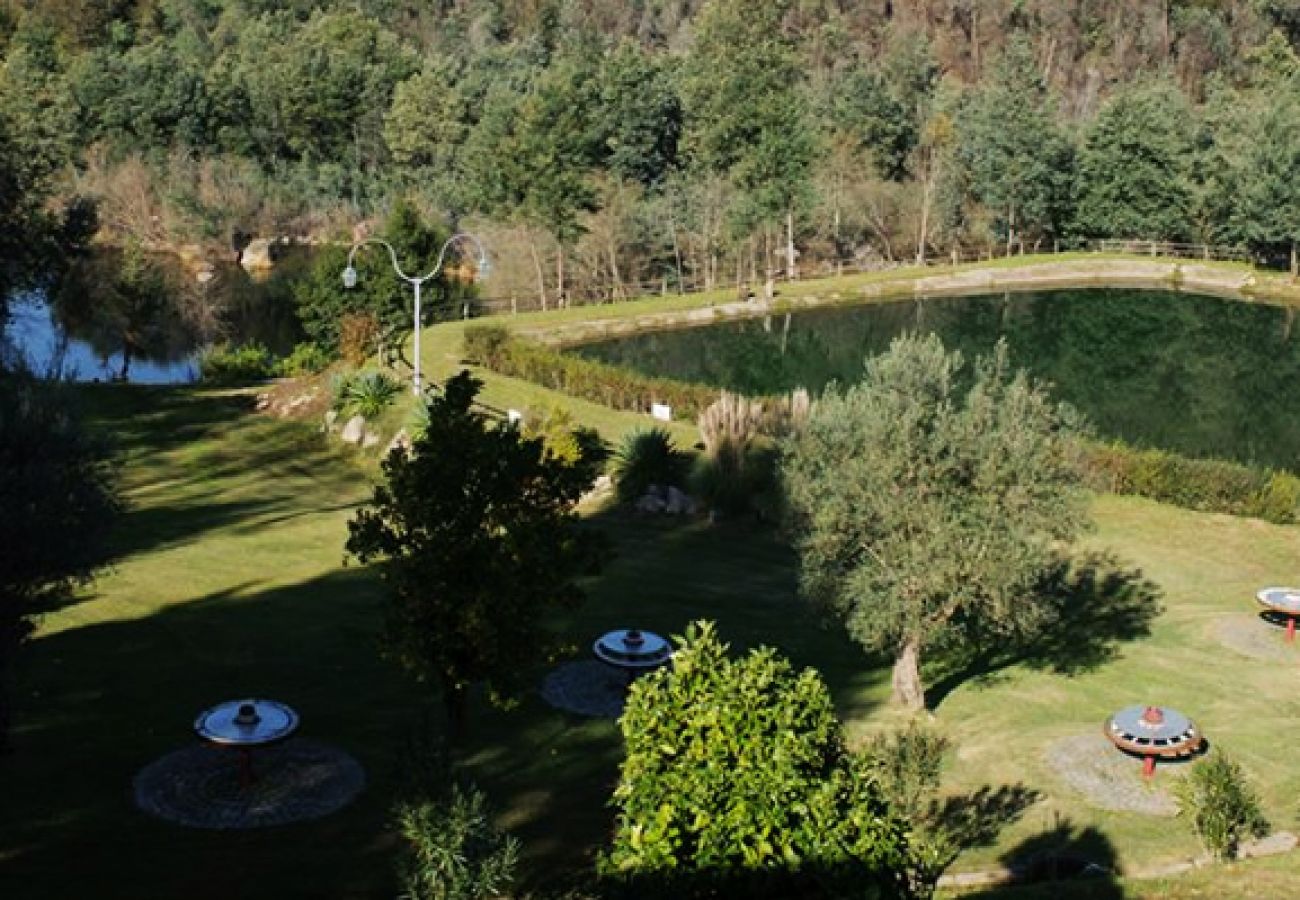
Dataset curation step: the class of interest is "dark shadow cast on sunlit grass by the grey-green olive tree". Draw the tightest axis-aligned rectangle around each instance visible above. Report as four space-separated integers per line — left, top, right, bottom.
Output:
927 551 1164 709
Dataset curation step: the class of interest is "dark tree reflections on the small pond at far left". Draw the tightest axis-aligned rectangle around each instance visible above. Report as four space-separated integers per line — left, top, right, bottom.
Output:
49 248 302 380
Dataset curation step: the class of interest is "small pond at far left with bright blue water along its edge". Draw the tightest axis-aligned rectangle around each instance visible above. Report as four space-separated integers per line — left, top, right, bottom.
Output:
4 252 303 384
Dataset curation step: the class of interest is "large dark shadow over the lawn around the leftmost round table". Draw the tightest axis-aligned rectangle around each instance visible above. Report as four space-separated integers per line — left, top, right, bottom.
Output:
0 569 423 900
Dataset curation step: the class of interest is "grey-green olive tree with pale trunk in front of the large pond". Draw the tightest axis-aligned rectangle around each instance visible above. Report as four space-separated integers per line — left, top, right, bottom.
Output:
783 334 1084 709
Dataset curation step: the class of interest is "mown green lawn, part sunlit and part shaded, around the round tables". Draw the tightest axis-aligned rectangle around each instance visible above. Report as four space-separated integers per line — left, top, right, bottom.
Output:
0 343 1300 900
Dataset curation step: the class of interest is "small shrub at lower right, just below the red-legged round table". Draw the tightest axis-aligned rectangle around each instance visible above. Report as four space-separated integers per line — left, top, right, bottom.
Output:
1177 750 1269 860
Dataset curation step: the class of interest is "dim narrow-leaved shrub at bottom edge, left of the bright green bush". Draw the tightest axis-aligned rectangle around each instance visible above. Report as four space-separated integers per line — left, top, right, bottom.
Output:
397 787 519 900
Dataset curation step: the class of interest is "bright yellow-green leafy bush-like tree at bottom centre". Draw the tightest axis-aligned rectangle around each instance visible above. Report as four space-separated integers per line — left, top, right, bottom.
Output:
602 622 915 897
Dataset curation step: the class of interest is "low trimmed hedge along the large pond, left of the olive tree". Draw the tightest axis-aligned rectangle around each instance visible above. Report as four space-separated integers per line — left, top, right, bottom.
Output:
463 325 738 421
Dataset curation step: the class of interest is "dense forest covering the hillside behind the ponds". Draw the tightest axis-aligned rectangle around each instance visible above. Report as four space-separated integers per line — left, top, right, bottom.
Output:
0 0 1300 309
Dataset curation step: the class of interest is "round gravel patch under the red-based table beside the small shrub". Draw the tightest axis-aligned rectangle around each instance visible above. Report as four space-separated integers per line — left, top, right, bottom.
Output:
1047 728 1180 815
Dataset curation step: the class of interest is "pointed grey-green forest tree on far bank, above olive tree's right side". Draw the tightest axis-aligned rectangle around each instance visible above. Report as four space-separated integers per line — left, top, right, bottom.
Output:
957 39 1073 252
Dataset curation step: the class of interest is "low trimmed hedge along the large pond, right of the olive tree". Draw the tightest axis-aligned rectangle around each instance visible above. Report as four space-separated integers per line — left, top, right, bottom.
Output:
1083 442 1300 524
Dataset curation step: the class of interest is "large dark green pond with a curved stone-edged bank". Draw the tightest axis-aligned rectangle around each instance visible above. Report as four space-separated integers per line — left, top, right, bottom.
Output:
575 289 1300 470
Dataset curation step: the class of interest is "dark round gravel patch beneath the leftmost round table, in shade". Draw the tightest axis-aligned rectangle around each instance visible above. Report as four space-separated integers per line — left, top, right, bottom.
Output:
135 739 365 830
